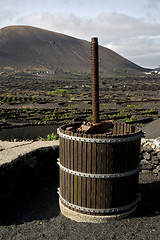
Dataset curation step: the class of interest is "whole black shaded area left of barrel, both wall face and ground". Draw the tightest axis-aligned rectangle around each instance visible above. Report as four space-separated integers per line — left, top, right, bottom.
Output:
0 146 59 225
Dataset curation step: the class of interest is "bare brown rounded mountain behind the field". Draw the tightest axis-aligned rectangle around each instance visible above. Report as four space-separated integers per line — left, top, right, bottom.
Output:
0 26 144 72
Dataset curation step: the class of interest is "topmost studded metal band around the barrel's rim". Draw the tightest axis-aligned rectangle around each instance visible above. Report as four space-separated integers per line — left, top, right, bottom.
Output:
57 128 143 143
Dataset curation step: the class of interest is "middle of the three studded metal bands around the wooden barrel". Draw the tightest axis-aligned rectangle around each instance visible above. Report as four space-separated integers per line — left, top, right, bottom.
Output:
57 160 142 179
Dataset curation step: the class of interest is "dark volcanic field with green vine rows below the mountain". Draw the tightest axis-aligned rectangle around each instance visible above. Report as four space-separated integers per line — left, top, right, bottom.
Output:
0 68 160 140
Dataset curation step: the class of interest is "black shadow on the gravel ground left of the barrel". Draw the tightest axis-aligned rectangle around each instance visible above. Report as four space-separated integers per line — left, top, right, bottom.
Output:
1 180 59 225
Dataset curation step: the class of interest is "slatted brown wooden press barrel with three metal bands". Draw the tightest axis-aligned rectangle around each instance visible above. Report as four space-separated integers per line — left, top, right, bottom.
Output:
58 122 142 222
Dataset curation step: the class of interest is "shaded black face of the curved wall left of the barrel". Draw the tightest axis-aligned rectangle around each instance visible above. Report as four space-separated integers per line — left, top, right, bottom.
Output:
0 146 59 211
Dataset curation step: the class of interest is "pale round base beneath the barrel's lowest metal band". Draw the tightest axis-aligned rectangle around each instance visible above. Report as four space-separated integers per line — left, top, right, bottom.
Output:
59 199 137 223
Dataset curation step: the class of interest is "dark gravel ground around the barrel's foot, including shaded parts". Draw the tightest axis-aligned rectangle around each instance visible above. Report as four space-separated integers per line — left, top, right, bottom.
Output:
0 173 160 240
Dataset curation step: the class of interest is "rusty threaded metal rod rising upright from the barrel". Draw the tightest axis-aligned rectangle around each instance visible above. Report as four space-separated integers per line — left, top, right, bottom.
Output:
91 37 99 124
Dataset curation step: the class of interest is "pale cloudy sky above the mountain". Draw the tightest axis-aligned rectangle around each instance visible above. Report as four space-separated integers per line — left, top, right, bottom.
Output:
0 0 160 68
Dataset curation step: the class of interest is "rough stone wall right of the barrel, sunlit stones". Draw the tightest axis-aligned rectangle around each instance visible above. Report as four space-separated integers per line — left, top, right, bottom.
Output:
140 139 160 175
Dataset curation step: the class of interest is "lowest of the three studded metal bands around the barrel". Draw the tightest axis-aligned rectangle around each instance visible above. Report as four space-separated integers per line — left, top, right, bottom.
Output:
58 189 141 214
